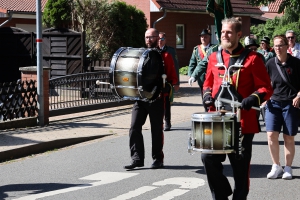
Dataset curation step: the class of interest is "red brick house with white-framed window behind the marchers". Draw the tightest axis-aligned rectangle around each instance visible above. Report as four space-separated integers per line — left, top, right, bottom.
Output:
123 0 264 67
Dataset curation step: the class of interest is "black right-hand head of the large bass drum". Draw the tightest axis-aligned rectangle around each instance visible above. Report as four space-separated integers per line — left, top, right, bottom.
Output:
139 49 164 100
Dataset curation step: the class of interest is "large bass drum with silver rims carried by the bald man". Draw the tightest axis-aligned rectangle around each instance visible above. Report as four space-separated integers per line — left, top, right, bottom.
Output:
109 47 164 101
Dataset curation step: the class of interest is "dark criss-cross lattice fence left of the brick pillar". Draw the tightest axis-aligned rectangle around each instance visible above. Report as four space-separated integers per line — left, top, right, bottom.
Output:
0 80 37 121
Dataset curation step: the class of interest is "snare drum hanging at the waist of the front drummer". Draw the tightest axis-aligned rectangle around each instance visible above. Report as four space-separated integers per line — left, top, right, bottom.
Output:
190 112 235 154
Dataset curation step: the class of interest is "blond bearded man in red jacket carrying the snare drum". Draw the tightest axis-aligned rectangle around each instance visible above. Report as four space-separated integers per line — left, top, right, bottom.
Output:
201 18 273 200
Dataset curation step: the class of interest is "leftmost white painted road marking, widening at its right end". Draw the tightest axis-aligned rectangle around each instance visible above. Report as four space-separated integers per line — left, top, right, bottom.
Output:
15 172 138 200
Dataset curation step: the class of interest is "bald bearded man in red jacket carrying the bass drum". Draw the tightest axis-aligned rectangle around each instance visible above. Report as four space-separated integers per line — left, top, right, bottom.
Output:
124 28 178 169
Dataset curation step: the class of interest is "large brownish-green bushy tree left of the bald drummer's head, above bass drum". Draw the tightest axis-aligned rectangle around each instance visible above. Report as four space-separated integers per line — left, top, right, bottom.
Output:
72 0 147 59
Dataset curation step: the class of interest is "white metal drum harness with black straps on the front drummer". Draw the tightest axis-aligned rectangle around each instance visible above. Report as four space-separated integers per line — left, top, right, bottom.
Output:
215 49 251 159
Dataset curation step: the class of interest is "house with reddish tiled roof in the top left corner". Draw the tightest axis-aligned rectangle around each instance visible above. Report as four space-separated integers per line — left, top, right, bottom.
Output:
0 0 47 32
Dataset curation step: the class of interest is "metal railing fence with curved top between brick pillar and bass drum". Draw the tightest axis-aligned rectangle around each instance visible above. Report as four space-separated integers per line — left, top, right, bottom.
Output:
49 70 128 116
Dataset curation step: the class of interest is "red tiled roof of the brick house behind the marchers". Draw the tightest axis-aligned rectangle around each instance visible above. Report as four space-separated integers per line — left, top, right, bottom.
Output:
153 0 263 15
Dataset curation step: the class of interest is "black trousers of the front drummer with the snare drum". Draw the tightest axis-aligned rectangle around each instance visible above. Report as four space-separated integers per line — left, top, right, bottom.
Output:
201 134 254 200
